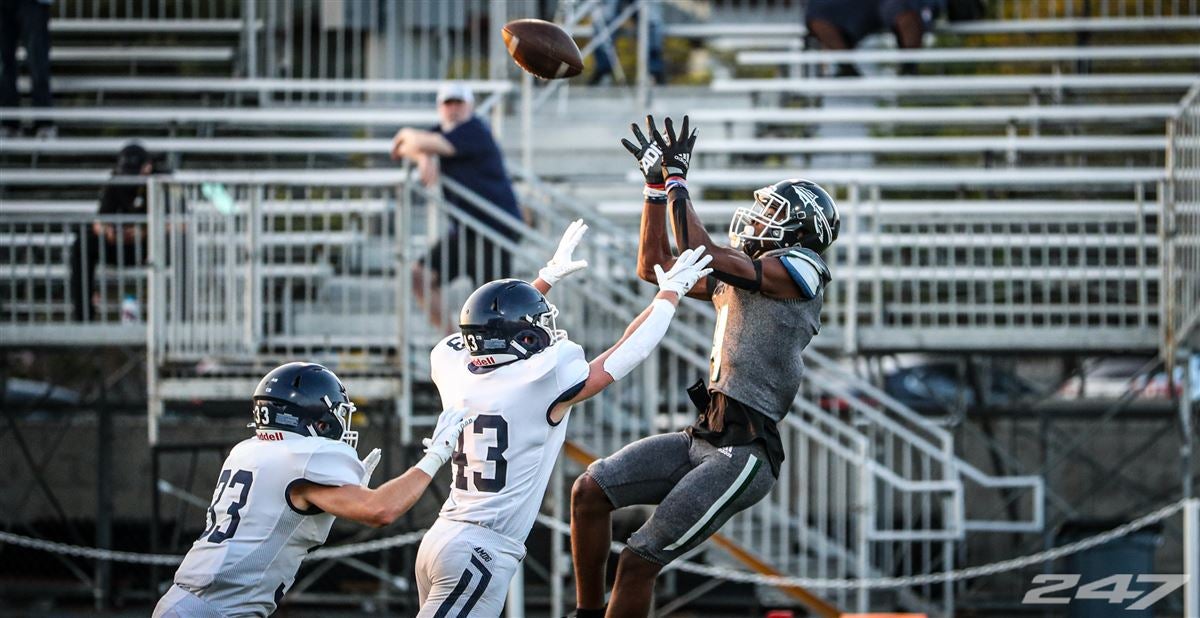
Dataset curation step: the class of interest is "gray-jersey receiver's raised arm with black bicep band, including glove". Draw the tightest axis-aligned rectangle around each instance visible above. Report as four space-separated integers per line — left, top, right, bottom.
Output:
647 116 800 298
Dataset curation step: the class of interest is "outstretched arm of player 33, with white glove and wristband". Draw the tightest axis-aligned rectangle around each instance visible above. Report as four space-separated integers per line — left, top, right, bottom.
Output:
288 409 475 528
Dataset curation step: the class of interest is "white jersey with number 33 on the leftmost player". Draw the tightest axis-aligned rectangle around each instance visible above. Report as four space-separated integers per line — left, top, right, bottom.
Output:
175 430 364 617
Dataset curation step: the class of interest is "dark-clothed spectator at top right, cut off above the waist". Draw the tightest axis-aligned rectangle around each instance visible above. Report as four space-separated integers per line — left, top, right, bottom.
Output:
804 0 925 77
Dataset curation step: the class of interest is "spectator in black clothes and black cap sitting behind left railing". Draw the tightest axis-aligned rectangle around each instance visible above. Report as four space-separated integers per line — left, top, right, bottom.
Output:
71 142 164 322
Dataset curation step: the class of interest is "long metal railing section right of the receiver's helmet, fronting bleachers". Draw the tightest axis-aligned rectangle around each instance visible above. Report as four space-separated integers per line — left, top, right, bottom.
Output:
828 184 1162 352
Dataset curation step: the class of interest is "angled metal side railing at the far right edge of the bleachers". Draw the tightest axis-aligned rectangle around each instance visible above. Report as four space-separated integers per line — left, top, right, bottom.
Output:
1162 83 1200 365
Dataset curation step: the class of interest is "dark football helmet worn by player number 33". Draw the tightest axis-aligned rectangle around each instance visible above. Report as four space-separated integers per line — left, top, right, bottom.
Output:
251 362 359 448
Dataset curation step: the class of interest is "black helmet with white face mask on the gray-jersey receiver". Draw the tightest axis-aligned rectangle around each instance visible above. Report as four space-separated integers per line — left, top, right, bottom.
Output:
730 179 841 258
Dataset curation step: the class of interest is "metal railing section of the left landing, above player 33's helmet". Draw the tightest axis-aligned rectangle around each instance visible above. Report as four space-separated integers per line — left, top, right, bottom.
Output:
149 173 398 366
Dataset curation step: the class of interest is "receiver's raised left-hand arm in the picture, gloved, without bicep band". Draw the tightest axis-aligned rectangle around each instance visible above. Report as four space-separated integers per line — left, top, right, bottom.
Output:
620 116 712 300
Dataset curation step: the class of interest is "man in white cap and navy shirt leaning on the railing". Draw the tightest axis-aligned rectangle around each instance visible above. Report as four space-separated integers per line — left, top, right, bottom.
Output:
391 82 521 329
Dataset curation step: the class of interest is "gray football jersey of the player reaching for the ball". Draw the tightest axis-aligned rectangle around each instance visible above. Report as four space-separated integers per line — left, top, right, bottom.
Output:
708 248 829 422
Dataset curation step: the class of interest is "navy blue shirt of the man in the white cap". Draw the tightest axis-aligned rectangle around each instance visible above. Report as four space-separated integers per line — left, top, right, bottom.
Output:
433 115 521 233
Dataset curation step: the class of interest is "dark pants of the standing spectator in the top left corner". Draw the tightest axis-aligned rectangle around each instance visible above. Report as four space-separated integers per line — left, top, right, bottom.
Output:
0 0 53 130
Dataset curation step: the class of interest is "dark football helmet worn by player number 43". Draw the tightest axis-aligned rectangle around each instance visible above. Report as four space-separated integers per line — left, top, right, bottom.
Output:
458 278 566 367
